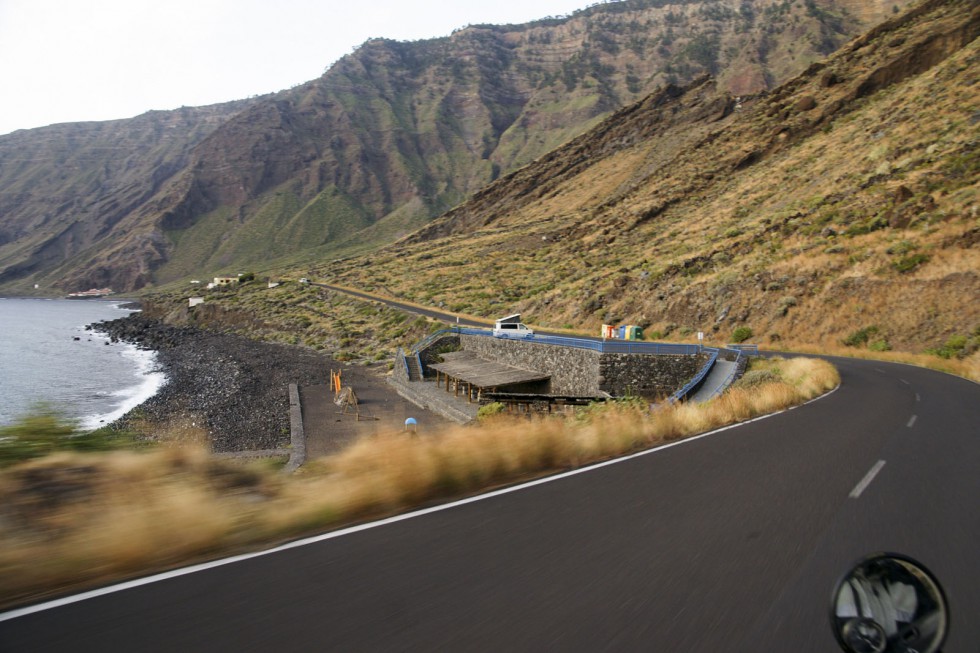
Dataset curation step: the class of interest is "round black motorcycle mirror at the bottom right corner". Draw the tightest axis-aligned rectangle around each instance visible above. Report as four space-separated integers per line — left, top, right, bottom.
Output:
830 553 949 653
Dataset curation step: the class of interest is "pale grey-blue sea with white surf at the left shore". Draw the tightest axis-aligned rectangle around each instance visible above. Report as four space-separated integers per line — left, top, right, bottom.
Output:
0 298 165 429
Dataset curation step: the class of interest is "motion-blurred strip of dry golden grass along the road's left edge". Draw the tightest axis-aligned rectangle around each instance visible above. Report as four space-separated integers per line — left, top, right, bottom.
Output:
0 358 839 607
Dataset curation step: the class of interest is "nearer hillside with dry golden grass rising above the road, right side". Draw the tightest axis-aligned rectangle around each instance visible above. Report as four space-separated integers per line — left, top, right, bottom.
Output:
328 0 980 350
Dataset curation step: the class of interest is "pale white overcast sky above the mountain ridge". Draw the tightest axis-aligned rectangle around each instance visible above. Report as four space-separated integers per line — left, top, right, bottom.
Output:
0 0 593 134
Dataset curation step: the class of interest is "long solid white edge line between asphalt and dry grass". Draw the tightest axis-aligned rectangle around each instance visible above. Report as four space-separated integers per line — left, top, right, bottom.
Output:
0 384 844 622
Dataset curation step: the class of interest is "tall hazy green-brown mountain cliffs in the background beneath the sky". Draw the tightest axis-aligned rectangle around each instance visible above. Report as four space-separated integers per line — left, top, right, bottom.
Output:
0 0 907 291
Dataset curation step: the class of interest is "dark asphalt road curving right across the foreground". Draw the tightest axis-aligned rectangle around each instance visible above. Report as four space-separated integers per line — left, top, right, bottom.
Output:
0 359 980 653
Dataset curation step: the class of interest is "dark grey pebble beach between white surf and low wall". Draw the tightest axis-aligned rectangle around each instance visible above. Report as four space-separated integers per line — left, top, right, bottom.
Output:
88 313 340 453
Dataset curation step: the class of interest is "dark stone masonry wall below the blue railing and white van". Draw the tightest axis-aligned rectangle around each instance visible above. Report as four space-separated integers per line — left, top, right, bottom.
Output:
460 335 707 399
